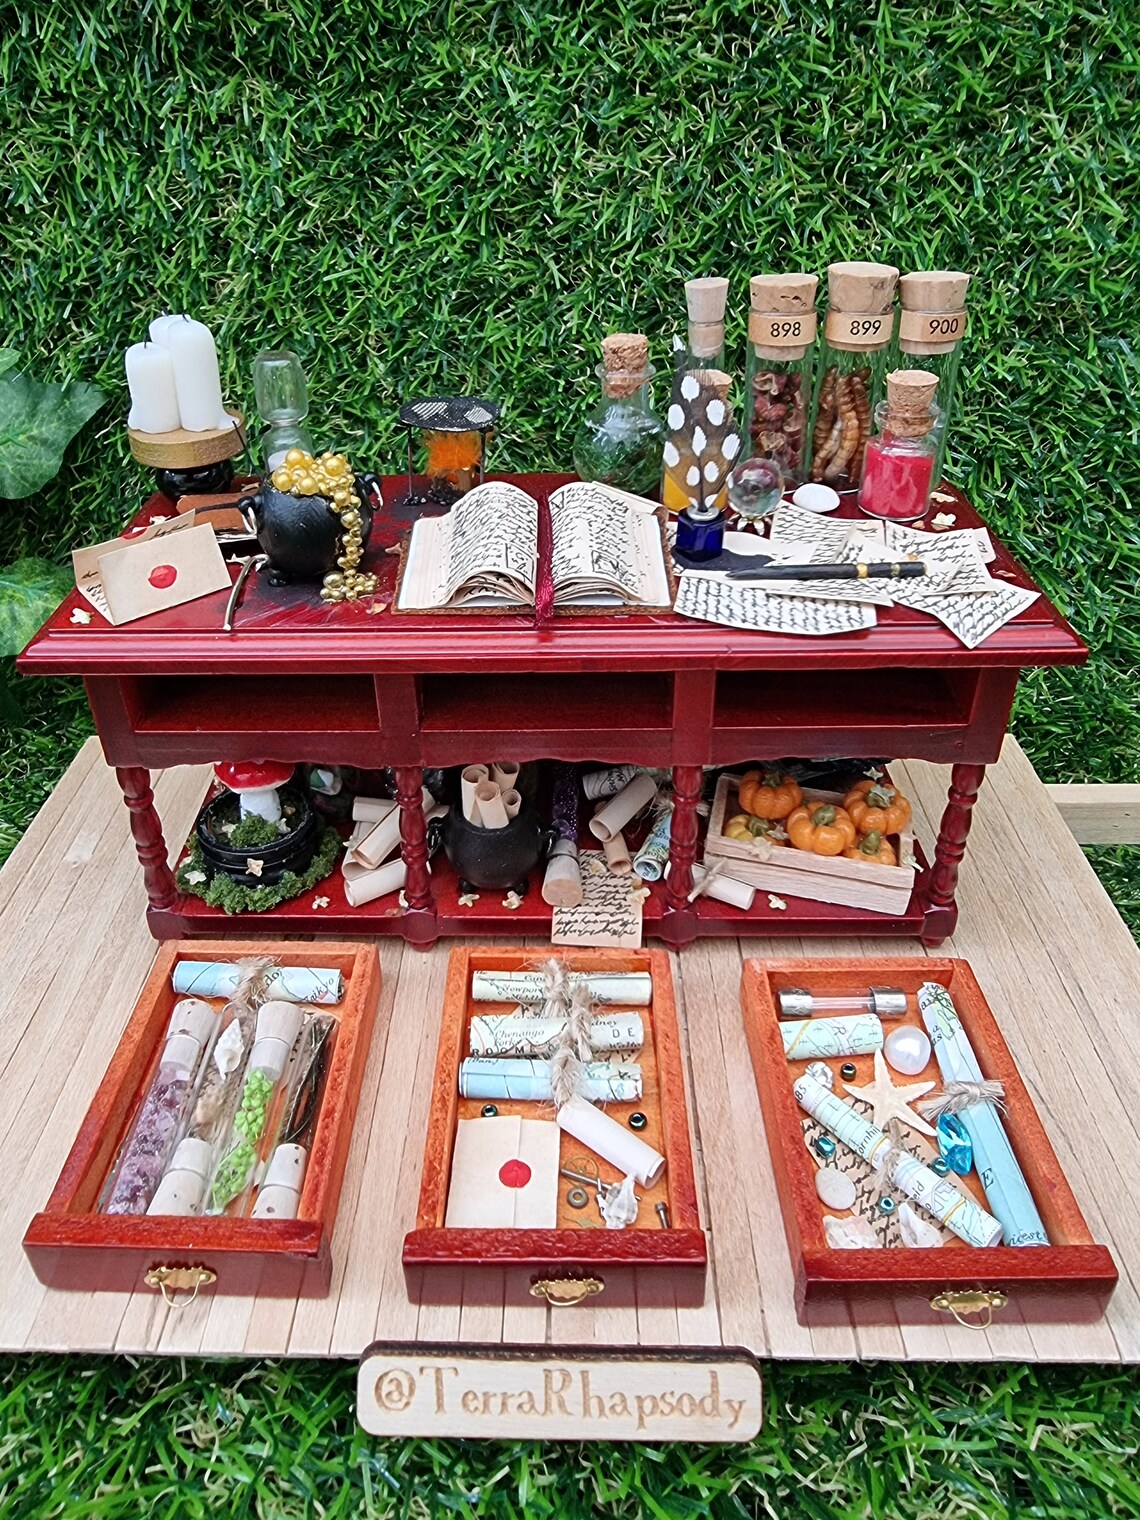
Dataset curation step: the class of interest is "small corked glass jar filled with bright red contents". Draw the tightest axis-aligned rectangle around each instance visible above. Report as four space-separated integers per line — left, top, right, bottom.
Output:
859 369 939 523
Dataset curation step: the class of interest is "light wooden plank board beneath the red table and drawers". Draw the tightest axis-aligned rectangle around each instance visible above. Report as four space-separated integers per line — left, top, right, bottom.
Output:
0 740 1140 1362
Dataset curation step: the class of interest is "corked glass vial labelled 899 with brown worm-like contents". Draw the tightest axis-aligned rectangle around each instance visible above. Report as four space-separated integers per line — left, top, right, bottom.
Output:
812 261 898 491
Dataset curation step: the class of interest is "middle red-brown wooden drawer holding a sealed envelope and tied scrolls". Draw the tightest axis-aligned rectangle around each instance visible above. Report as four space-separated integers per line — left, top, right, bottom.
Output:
403 948 707 1304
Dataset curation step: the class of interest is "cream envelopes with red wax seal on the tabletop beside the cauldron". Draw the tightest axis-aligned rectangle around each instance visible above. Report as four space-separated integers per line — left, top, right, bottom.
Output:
71 512 230 625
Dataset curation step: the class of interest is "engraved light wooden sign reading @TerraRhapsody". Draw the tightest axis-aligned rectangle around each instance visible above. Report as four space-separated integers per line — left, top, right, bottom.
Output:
356 1341 763 1441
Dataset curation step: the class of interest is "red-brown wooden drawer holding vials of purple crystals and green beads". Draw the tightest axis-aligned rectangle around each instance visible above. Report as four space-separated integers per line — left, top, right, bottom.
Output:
24 939 380 1297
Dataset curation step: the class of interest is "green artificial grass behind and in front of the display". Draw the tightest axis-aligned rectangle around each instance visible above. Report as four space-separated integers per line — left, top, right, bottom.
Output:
0 0 1140 1520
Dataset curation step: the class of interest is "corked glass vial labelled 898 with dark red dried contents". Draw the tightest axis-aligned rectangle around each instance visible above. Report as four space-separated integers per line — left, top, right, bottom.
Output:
745 274 819 486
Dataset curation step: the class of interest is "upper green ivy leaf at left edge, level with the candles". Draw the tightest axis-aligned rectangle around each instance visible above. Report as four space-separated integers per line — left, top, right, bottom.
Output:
0 370 106 502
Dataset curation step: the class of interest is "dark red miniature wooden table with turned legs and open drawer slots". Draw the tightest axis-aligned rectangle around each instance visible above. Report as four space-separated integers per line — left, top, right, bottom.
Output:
18 474 1087 945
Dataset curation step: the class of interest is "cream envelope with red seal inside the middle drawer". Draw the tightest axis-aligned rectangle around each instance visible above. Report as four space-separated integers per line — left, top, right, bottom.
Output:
444 1114 561 1230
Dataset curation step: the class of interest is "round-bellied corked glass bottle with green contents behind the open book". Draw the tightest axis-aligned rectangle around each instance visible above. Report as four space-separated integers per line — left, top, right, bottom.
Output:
572 333 664 496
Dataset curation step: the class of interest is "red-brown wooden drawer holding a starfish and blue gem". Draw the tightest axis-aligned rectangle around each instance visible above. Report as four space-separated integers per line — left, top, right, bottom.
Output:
742 958 1117 1324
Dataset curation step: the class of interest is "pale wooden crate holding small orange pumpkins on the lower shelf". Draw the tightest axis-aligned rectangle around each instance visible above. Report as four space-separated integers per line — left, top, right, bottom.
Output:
704 775 915 915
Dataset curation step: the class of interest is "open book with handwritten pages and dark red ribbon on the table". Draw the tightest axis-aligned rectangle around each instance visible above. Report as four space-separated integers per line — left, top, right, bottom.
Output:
395 480 672 613
